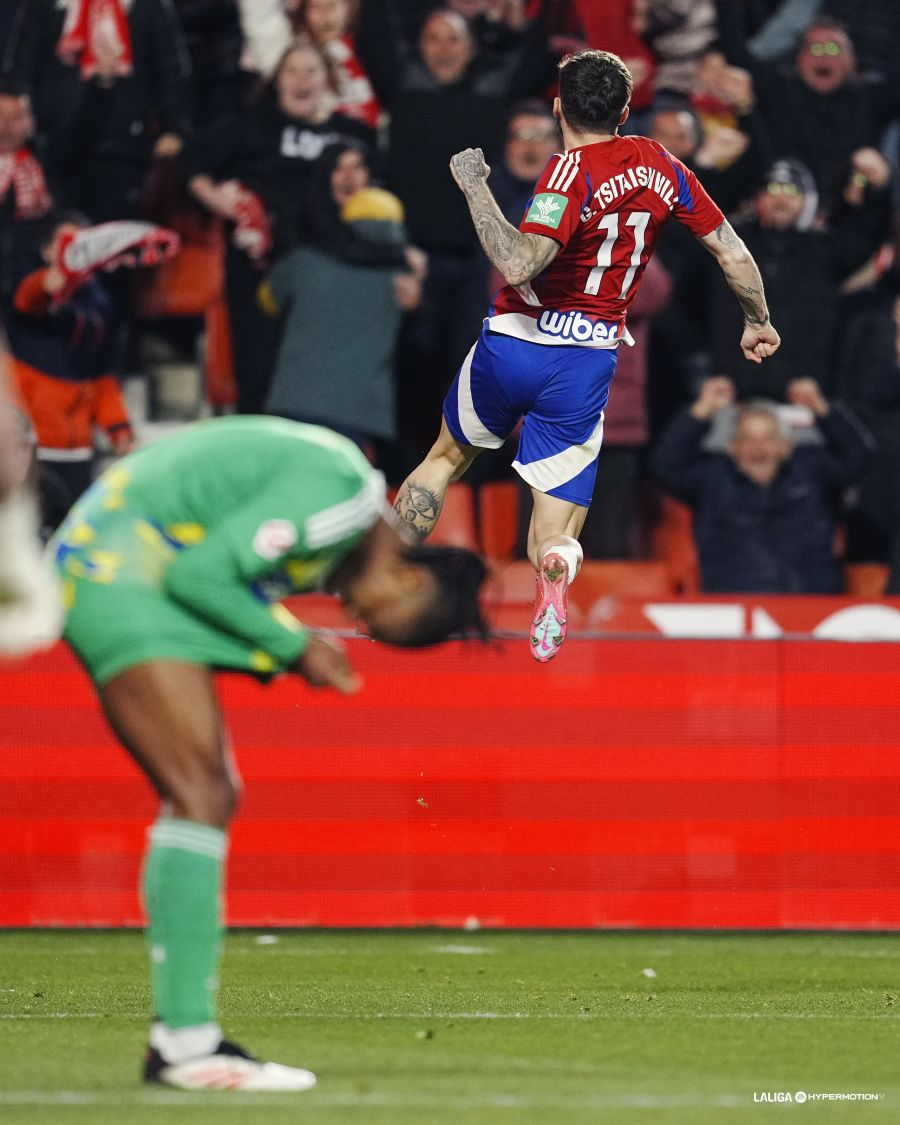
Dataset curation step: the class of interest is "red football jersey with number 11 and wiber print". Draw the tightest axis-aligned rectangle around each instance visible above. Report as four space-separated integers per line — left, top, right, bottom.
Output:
489 136 725 348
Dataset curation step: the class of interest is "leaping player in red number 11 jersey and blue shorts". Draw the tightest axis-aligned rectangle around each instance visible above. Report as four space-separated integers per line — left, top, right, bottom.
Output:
394 51 780 662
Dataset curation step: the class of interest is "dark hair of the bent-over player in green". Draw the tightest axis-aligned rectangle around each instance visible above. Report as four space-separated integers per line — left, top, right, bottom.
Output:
399 543 489 648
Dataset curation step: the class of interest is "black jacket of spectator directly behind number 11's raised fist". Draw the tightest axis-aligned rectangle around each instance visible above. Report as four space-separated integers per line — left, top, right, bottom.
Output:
357 0 554 253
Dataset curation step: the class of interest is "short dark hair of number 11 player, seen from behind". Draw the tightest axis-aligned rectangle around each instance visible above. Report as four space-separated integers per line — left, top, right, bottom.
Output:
559 51 635 133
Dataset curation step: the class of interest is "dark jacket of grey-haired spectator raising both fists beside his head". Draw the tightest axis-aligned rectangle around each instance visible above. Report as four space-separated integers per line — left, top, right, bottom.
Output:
651 404 872 594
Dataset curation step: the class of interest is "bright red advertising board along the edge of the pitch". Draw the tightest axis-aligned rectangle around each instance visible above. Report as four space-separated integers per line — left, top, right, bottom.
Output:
0 630 900 928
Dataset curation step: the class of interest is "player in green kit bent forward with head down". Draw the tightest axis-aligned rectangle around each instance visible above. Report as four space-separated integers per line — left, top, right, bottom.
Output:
52 417 485 1090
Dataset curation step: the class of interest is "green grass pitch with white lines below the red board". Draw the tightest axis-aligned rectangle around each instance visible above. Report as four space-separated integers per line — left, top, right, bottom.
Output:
0 930 900 1125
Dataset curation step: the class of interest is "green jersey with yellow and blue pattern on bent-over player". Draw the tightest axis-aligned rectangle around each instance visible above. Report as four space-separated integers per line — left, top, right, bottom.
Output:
53 416 385 672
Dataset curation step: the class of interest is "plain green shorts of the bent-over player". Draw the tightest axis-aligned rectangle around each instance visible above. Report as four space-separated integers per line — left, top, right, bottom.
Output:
63 577 279 684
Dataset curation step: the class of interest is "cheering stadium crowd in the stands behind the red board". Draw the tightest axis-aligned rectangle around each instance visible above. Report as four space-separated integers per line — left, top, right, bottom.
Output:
0 0 900 593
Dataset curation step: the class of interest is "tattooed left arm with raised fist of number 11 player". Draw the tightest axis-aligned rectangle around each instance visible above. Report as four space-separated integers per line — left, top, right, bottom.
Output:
450 149 559 285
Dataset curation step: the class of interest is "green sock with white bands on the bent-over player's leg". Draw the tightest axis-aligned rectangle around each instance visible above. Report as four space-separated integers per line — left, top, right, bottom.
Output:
144 817 227 1028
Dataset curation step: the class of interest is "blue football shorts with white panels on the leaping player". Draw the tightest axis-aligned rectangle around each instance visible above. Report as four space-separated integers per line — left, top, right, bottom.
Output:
443 326 617 507
